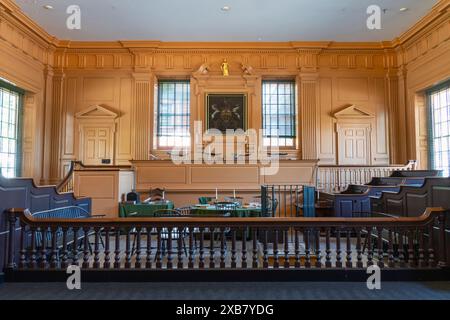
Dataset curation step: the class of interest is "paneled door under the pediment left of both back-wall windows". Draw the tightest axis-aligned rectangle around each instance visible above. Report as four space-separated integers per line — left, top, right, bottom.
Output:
81 127 114 165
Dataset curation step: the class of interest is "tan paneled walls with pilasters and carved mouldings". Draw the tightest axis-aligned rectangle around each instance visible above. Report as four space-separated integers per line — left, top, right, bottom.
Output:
0 0 450 182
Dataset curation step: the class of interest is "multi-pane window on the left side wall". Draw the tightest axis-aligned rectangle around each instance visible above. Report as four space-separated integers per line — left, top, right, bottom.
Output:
0 80 22 178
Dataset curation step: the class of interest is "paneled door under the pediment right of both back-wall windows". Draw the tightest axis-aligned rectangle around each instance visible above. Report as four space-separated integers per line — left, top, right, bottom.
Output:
338 124 370 165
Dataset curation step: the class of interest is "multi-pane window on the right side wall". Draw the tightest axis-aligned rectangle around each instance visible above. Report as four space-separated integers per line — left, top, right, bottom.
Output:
428 81 450 176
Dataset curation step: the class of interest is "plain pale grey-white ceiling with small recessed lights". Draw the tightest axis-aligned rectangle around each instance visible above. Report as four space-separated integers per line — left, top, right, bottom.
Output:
16 0 438 41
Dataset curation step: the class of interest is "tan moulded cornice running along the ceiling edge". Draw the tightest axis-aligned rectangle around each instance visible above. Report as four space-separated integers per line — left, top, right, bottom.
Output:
0 0 450 63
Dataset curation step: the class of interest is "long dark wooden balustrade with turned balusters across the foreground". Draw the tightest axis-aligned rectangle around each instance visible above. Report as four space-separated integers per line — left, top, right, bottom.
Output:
7 208 450 272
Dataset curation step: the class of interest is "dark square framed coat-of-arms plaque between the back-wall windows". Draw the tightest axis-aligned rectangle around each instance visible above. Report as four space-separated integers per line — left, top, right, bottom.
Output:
206 93 247 133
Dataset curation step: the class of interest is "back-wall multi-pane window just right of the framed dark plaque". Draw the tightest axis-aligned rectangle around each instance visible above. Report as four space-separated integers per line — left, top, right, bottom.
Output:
262 81 296 147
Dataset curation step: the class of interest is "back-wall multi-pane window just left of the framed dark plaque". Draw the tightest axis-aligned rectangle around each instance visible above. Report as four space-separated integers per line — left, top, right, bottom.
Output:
156 80 191 148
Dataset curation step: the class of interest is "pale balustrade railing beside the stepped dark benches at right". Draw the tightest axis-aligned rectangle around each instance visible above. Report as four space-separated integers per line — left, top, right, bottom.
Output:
317 160 416 192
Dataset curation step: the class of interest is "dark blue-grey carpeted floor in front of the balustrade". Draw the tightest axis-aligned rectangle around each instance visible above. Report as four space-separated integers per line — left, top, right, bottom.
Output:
0 282 450 300
